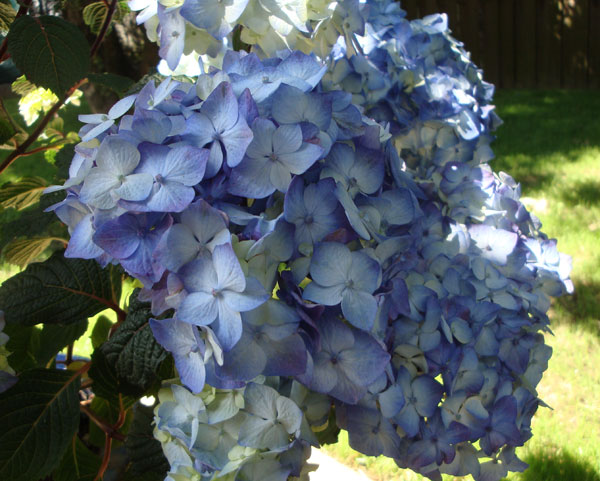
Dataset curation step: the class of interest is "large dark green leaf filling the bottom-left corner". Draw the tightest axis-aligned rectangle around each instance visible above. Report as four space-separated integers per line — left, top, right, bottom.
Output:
0 369 80 481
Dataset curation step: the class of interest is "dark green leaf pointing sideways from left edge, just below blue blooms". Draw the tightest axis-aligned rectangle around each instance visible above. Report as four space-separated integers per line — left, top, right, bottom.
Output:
0 252 121 326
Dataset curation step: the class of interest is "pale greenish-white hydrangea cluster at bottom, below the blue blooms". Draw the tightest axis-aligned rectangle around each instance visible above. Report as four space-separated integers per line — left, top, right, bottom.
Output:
155 380 329 481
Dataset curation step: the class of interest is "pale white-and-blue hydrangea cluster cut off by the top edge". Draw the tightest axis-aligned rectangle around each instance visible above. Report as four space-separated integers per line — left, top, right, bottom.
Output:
129 0 367 73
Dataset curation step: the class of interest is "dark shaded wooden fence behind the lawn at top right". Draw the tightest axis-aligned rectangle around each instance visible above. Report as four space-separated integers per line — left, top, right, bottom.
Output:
401 0 600 89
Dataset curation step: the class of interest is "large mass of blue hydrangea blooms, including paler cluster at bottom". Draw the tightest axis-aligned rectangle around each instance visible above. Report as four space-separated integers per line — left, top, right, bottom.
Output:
54 1 572 481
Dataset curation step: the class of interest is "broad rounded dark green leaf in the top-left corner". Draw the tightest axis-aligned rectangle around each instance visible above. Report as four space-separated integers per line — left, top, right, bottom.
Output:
6 15 90 97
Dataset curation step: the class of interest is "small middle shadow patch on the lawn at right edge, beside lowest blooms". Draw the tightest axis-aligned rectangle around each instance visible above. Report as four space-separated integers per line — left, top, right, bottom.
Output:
550 282 600 337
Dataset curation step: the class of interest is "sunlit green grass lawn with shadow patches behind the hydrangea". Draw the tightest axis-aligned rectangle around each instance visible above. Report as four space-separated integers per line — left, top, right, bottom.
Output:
324 91 600 481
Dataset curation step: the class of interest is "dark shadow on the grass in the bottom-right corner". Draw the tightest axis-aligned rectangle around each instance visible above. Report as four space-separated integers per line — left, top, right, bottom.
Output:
518 449 600 481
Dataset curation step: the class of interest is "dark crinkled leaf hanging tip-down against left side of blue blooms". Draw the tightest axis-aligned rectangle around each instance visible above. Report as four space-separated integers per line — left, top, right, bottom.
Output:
100 291 167 396
